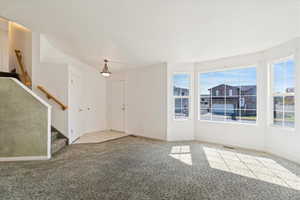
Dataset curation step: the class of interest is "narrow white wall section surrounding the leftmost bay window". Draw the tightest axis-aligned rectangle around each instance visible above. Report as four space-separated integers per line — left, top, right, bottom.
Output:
167 63 195 141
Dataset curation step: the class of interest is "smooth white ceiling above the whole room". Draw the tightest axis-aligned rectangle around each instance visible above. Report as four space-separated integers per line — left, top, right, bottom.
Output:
0 0 300 70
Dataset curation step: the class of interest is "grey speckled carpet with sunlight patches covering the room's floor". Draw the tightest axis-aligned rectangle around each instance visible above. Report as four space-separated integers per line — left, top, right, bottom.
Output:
0 136 300 200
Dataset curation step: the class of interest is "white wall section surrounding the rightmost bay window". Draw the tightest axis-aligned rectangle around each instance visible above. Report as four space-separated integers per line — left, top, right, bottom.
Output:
264 38 300 163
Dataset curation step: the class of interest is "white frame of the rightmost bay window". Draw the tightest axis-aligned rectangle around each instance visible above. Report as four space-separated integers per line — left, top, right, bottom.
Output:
269 54 297 131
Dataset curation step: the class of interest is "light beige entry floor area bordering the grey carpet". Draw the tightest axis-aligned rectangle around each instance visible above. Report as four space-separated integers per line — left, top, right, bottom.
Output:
74 131 128 144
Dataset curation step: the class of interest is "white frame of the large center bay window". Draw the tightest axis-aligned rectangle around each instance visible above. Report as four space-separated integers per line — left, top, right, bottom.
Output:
197 63 260 126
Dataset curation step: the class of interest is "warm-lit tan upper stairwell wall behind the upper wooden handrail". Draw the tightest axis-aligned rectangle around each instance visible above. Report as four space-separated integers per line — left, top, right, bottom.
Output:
9 22 32 77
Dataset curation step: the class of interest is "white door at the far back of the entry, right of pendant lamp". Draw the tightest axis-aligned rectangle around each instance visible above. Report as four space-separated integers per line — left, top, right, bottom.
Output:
110 81 125 132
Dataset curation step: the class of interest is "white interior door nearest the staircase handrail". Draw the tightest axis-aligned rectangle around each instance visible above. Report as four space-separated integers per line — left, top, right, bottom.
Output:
69 72 85 143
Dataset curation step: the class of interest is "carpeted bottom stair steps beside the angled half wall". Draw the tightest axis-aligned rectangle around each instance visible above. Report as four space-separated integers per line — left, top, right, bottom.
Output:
51 127 68 155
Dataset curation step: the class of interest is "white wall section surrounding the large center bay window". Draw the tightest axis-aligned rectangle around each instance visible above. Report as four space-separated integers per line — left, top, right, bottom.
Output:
195 53 267 150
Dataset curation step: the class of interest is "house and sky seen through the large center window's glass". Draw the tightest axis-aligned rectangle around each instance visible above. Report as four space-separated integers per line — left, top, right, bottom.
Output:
199 67 256 123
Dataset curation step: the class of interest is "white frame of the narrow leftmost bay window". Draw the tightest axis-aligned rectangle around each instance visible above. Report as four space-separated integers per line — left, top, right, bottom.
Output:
171 72 192 121
